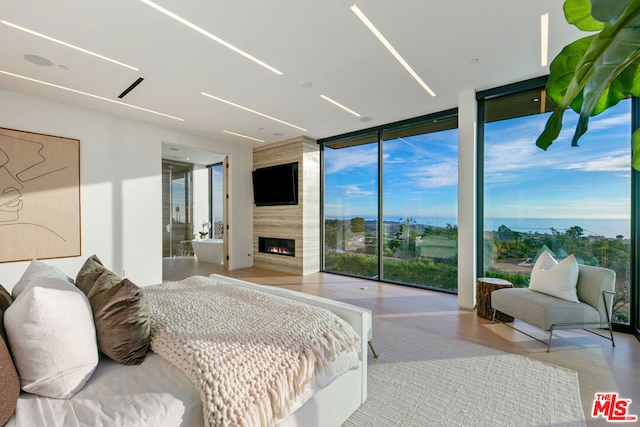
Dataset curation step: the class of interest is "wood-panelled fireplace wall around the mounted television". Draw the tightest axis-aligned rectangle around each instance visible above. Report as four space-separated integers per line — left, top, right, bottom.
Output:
253 136 320 275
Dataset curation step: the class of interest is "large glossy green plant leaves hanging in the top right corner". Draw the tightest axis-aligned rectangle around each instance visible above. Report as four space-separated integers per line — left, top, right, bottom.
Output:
536 0 640 150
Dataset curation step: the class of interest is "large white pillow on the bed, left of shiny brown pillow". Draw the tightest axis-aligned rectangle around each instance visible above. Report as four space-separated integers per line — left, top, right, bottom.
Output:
4 265 98 399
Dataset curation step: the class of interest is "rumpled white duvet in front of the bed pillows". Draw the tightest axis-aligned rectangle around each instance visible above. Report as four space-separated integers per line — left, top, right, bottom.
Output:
7 353 202 427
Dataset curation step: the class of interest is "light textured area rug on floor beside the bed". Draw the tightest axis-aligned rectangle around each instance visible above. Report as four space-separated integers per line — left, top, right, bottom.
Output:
344 319 586 427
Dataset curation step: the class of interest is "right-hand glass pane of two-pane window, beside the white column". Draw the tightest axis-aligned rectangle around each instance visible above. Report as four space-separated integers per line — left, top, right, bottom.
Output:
382 117 458 291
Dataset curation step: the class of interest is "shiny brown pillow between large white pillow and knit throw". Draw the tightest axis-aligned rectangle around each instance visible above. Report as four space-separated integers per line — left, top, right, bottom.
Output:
76 255 150 365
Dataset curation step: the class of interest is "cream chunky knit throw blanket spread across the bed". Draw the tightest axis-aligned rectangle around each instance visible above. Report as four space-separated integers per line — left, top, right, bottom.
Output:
144 276 360 426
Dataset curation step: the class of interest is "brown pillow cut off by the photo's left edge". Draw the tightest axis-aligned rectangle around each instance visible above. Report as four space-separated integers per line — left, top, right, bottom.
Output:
0 285 20 425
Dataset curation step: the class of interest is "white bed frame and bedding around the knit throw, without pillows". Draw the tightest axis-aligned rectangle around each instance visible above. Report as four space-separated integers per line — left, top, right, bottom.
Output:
7 275 372 427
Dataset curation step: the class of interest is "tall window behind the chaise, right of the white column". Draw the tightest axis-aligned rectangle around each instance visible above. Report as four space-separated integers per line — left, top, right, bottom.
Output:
479 80 634 325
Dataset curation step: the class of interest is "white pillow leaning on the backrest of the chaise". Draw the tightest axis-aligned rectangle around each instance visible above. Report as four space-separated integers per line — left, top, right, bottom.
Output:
529 250 580 303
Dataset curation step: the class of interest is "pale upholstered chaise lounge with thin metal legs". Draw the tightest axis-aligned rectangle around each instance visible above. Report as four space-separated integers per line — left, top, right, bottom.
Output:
491 264 616 351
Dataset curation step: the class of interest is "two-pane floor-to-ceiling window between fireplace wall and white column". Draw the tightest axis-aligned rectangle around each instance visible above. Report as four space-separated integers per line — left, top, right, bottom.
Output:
321 111 458 292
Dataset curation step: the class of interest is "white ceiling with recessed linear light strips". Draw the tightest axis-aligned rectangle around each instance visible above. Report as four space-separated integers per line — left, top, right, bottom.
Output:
0 0 581 152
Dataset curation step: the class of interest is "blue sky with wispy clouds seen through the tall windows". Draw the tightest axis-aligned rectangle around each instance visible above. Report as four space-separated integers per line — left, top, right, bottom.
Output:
325 100 631 236
